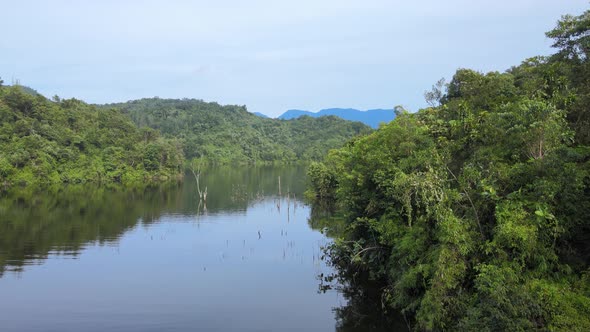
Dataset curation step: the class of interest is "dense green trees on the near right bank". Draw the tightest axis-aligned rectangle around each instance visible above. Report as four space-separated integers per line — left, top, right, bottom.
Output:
308 11 590 331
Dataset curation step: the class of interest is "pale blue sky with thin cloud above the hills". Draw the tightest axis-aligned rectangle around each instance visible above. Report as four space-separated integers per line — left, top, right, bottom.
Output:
0 0 590 117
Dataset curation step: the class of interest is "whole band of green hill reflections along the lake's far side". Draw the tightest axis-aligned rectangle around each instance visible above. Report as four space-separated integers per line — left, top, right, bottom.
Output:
0 167 305 277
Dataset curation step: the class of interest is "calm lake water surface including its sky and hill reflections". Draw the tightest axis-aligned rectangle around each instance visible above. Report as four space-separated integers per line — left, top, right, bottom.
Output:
0 167 346 331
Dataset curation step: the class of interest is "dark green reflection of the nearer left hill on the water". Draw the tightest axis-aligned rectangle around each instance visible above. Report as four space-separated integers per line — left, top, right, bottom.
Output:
0 186 166 276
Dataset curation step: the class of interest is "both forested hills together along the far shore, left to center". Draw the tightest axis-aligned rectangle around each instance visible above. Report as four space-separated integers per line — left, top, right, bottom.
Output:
0 80 371 191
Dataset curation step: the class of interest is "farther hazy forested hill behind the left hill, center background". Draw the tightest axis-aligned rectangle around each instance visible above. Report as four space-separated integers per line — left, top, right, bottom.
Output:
100 98 371 163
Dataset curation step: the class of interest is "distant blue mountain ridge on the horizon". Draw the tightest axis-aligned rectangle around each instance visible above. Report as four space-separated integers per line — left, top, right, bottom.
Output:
279 108 395 128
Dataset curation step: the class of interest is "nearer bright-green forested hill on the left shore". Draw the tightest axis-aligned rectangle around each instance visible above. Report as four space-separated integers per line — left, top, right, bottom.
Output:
0 84 184 191
